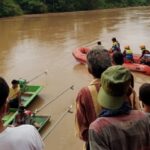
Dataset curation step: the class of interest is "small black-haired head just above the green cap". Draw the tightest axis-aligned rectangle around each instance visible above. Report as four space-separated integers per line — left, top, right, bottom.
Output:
112 52 124 65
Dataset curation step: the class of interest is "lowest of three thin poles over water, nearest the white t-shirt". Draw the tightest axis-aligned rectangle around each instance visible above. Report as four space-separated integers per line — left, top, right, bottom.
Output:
42 105 72 141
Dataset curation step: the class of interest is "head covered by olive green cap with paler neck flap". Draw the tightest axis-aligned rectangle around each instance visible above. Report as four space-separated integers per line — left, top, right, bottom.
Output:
98 65 131 110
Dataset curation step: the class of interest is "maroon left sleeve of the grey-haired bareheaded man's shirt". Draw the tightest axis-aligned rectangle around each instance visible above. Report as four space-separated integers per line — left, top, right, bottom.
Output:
75 89 89 141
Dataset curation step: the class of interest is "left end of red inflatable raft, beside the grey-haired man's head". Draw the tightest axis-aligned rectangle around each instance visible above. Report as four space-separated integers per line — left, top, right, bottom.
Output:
72 47 90 64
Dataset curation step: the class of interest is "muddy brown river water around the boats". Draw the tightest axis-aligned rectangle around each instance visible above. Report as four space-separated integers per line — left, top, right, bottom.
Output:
0 7 150 150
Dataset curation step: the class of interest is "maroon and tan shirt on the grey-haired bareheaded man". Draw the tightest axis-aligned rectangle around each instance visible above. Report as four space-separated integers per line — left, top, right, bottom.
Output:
75 79 101 141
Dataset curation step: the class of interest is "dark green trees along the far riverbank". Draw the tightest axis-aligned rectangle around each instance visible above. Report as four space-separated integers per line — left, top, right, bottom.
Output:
0 0 150 17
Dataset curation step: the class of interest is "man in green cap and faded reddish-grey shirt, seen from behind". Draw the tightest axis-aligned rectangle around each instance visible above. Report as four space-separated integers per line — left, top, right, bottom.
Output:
89 66 150 150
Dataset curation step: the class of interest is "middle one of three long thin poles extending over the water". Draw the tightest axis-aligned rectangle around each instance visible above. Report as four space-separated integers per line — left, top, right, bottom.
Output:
35 85 74 113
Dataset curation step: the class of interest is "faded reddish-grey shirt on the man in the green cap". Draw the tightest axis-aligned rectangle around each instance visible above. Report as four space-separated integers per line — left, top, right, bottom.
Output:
89 110 150 150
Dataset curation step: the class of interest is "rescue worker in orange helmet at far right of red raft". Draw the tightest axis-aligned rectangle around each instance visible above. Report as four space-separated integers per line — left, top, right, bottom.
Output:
140 45 150 66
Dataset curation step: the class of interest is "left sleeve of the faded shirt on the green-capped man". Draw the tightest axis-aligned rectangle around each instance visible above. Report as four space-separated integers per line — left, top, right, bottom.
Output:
89 129 109 150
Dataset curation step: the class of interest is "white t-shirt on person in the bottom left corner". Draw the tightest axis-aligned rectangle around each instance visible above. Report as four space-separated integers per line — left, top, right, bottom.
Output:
0 125 43 150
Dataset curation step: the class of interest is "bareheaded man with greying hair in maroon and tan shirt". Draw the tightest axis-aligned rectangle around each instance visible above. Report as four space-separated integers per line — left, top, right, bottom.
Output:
75 49 111 149
